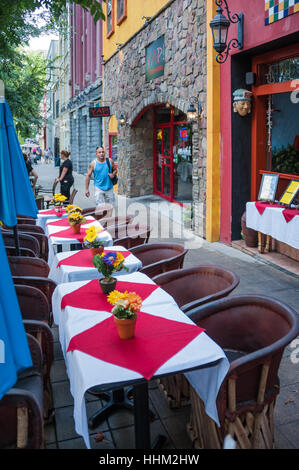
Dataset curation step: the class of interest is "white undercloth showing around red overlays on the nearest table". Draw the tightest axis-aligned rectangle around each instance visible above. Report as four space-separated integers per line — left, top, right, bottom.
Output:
53 273 229 448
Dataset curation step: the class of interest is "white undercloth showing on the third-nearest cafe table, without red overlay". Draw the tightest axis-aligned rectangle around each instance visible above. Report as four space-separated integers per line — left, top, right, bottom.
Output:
45 216 113 266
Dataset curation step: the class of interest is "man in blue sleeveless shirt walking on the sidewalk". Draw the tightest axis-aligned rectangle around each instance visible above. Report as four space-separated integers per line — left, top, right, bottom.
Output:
85 147 117 206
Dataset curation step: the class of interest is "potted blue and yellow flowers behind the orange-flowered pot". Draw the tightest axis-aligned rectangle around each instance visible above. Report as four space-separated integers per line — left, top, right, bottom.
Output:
92 251 128 294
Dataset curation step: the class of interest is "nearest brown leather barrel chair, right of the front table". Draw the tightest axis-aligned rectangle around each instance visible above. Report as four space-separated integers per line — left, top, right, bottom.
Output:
187 295 299 449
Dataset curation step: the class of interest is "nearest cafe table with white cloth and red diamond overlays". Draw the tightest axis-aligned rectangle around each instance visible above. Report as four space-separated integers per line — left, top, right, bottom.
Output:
53 272 229 449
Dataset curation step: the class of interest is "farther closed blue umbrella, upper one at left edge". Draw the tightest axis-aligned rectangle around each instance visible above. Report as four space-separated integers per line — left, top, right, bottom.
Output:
0 98 38 227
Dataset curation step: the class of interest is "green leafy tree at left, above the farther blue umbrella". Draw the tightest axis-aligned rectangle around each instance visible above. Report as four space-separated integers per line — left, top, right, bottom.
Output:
0 49 46 138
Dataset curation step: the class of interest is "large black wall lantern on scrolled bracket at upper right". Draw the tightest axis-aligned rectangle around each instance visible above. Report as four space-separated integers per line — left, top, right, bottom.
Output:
210 0 244 64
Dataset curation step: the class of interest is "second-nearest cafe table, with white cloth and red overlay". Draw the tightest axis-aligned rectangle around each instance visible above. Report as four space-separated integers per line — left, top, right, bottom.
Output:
49 246 142 284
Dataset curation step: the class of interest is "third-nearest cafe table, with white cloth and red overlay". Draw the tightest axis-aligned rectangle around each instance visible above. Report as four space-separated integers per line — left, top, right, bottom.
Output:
45 216 113 266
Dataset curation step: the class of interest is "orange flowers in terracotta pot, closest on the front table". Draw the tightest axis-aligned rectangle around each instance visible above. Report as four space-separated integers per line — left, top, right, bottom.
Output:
108 290 142 339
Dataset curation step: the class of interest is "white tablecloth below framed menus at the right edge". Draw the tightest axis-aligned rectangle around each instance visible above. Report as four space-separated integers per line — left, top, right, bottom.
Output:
246 202 299 249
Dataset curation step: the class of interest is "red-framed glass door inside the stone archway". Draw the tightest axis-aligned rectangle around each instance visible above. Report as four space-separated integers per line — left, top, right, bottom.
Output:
153 105 192 205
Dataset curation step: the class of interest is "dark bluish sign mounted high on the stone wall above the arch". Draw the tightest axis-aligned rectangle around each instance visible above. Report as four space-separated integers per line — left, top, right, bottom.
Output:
145 36 165 81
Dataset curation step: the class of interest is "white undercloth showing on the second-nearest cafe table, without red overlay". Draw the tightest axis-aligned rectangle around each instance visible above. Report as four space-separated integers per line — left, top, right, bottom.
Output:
49 246 142 284
